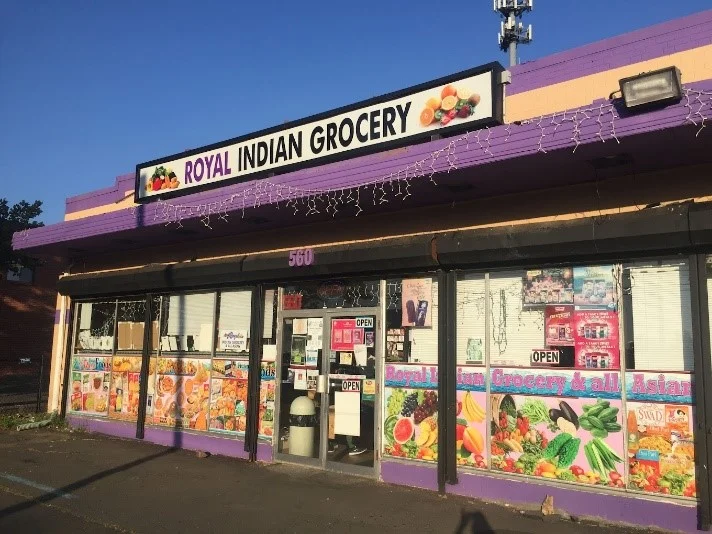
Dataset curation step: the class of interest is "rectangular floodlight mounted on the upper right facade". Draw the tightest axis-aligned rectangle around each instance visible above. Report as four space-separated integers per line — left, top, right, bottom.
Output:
619 67 682 110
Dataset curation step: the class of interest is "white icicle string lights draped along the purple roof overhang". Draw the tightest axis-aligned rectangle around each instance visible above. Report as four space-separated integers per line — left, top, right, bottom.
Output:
8 87 712 243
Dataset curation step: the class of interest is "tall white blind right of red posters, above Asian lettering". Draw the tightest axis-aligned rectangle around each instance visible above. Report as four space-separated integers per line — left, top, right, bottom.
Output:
630 264 694 371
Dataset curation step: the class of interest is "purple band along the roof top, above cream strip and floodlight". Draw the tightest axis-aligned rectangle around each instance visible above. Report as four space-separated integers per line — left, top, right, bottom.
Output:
507 10 712 95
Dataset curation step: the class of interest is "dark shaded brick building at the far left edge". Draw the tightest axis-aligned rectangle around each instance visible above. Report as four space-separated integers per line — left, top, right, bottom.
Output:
0 258 62 377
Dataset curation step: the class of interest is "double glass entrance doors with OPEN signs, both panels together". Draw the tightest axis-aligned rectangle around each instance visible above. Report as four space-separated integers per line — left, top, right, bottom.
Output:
275 308 380 476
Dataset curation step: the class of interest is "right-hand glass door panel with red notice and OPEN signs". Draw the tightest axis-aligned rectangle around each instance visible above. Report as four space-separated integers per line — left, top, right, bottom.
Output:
322 309 379 474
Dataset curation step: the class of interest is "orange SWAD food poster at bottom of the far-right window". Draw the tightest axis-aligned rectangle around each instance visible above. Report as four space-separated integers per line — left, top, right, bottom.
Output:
626 402 697 498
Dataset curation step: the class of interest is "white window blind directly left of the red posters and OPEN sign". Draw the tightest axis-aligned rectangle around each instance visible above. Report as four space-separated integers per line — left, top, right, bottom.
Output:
488 271 546 367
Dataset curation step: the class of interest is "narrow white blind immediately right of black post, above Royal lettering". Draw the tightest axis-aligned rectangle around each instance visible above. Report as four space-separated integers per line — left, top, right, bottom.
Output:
456 275 487 364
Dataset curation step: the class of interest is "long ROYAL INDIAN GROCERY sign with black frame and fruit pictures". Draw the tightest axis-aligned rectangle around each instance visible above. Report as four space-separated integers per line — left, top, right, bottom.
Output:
135 63 504 201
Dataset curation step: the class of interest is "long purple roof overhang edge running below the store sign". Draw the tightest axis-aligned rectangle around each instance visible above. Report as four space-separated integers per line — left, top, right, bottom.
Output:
13 80 712 255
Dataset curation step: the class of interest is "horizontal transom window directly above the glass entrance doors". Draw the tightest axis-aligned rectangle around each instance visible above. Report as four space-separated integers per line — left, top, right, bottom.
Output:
282 279 380 310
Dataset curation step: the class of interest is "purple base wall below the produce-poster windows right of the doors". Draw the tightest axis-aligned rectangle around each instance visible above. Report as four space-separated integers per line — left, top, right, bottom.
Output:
381 462 700 532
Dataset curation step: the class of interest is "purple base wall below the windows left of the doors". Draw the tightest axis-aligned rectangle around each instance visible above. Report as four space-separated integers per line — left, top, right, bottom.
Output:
67 415 272 462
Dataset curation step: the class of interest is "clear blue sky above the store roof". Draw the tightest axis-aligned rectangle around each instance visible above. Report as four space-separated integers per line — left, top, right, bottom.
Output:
0 0 710 223
